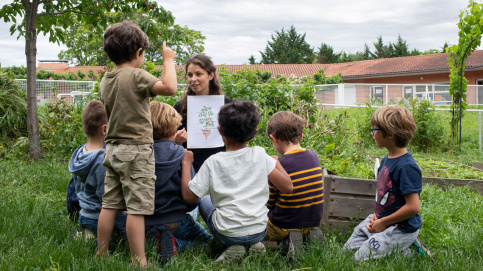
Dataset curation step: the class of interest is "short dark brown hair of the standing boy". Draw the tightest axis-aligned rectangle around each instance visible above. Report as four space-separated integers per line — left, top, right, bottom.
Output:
103 21 149 65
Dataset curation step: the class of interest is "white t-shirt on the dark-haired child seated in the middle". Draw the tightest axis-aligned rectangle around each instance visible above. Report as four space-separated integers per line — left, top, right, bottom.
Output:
189 147 277 237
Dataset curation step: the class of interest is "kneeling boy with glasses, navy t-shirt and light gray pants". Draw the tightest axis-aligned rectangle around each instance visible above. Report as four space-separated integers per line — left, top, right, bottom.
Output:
344 105 431 261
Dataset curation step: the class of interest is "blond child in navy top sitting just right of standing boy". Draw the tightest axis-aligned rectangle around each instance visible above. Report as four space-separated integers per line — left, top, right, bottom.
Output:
144 101 212 263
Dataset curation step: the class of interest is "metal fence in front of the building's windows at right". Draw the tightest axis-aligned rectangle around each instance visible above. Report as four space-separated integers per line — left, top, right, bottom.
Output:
316 83 483 106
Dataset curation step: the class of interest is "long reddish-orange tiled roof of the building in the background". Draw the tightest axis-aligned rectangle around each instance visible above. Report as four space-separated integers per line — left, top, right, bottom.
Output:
38 50 483 79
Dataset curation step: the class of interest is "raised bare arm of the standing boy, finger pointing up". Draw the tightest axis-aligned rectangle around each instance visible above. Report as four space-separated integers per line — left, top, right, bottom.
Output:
151 41 178 96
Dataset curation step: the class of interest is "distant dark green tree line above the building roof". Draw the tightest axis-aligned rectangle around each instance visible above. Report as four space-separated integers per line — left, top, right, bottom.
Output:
248 25 449 64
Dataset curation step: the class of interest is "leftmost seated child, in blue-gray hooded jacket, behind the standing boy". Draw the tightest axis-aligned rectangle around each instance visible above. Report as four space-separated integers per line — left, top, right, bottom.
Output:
69 100 127 240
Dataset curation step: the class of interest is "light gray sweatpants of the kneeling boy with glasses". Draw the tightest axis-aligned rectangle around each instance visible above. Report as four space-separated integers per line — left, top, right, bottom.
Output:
344 214 419 261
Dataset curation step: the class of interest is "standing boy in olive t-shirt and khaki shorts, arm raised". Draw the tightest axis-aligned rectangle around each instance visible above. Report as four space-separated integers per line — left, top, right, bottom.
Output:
98 21 177 267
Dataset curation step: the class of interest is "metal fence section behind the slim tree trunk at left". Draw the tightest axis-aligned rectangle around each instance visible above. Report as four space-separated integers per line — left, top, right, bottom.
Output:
16 79 97 104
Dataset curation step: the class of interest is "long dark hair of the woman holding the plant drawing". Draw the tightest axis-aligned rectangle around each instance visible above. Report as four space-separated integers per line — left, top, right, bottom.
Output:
180 55 223 120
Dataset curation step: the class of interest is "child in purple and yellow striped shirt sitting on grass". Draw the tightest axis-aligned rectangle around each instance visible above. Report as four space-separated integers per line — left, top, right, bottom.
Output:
265 111 324 259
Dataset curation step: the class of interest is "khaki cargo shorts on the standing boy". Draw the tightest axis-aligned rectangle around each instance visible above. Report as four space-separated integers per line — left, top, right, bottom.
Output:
102 143 156 215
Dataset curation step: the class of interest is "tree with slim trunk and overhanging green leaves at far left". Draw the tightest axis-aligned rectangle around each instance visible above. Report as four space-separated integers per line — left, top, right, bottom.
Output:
0 0 174 158
